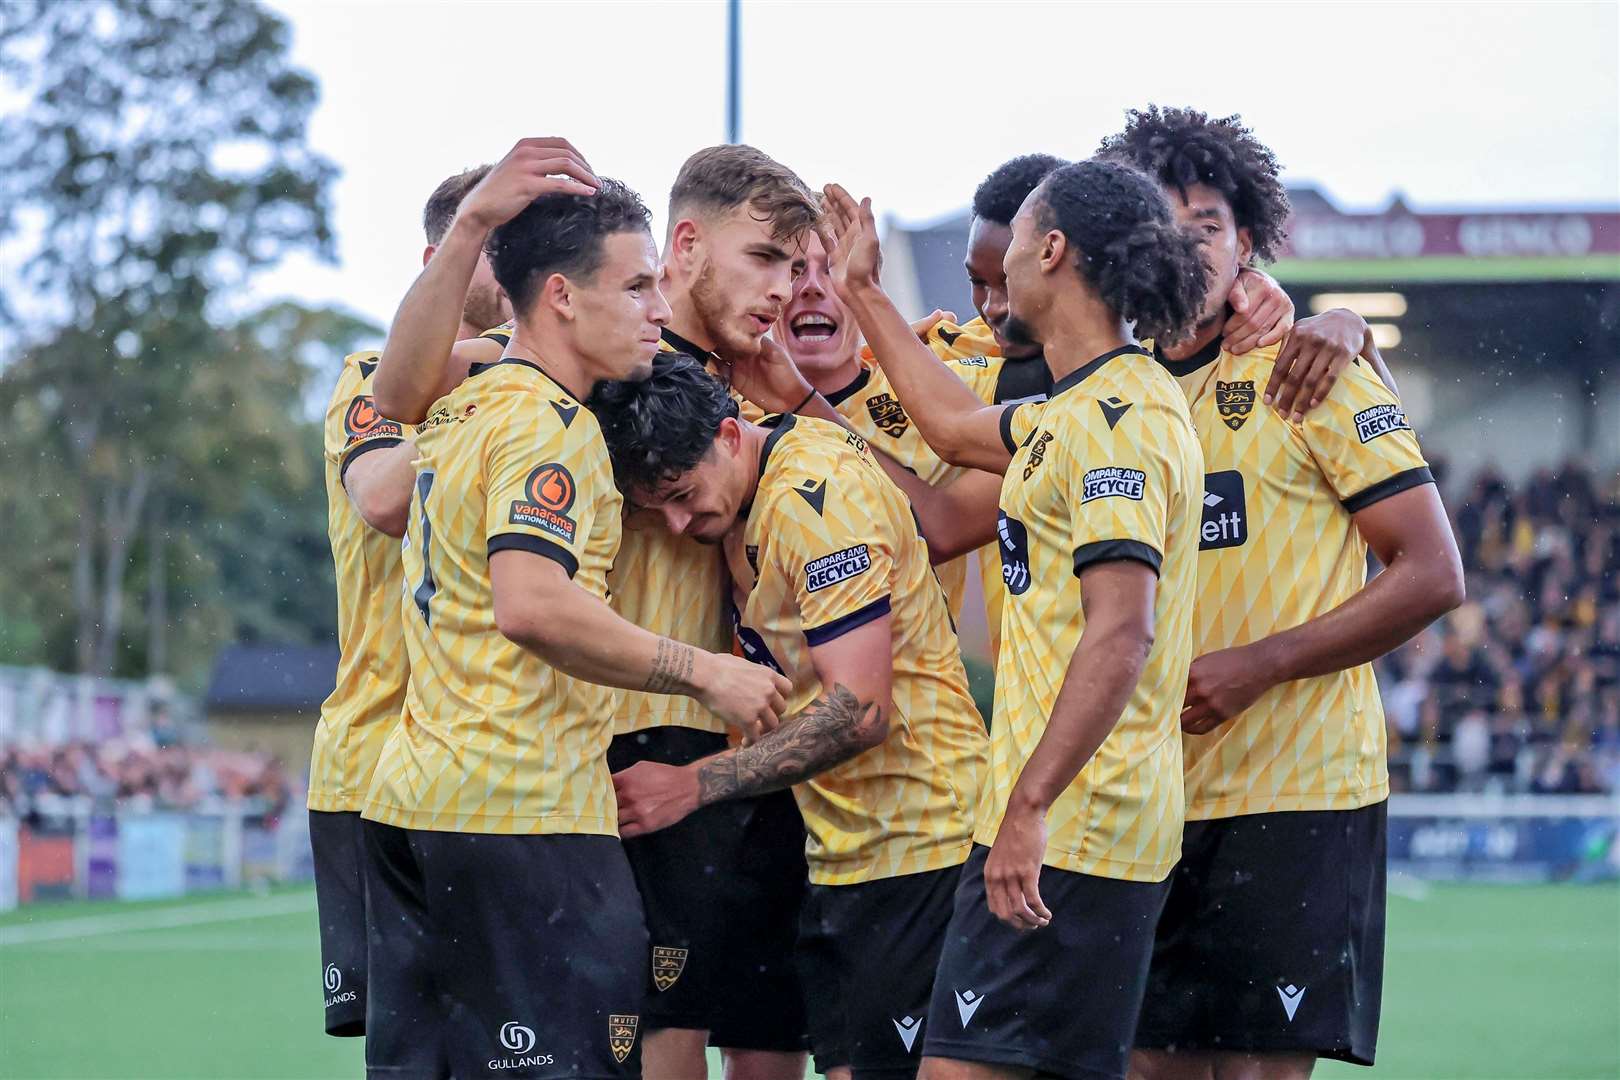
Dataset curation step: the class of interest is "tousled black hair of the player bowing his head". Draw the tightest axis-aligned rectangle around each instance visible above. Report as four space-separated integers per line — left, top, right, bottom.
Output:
590 353 739 495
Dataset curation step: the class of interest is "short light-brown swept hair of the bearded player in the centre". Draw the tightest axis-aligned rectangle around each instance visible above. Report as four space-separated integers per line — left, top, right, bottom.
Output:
669 144 821 240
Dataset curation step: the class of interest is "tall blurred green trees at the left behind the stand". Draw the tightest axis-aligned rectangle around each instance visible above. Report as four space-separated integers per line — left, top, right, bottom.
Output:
0 0 361 677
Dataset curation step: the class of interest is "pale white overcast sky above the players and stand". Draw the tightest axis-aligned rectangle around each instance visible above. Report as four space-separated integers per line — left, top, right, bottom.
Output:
258 0 1620 330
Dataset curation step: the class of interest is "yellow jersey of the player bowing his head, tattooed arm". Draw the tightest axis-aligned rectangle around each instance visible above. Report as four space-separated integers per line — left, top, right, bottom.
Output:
737 416 987 884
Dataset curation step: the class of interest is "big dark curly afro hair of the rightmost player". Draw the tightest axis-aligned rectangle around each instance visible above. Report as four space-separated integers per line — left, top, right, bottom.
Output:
1097 105 1290 262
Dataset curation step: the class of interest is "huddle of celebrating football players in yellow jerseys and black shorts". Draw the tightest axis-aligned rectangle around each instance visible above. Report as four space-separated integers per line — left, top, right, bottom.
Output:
309 107 1463 1080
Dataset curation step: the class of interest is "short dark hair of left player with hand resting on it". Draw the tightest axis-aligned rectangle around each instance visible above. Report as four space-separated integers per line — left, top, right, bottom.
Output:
484 176 653 311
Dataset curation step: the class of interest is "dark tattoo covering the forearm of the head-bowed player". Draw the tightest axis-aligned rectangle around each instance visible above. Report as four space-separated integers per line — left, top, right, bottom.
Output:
698 685 883 806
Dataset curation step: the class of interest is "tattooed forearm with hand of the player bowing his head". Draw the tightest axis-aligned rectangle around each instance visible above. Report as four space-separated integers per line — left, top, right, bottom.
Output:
612 685 888 837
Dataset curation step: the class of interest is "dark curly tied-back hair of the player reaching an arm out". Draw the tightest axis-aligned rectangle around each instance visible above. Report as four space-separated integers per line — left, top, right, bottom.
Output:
1034 159 1209 340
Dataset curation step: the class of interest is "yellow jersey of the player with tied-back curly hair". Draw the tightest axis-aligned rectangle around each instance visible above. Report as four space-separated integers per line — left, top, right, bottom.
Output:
977 347 1204 881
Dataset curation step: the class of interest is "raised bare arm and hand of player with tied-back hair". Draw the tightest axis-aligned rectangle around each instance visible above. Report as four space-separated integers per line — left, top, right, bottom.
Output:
821 185 1013 473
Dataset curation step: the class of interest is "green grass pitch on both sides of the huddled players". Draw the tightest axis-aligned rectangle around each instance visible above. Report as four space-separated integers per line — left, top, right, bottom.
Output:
0 886 1620 1080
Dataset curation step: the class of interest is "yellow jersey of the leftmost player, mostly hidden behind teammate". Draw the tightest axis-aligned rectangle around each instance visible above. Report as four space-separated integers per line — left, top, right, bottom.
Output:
309 353 411 813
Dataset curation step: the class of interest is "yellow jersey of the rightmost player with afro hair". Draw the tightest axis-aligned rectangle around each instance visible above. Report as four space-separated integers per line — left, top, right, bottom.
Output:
1163 342 1434 819
